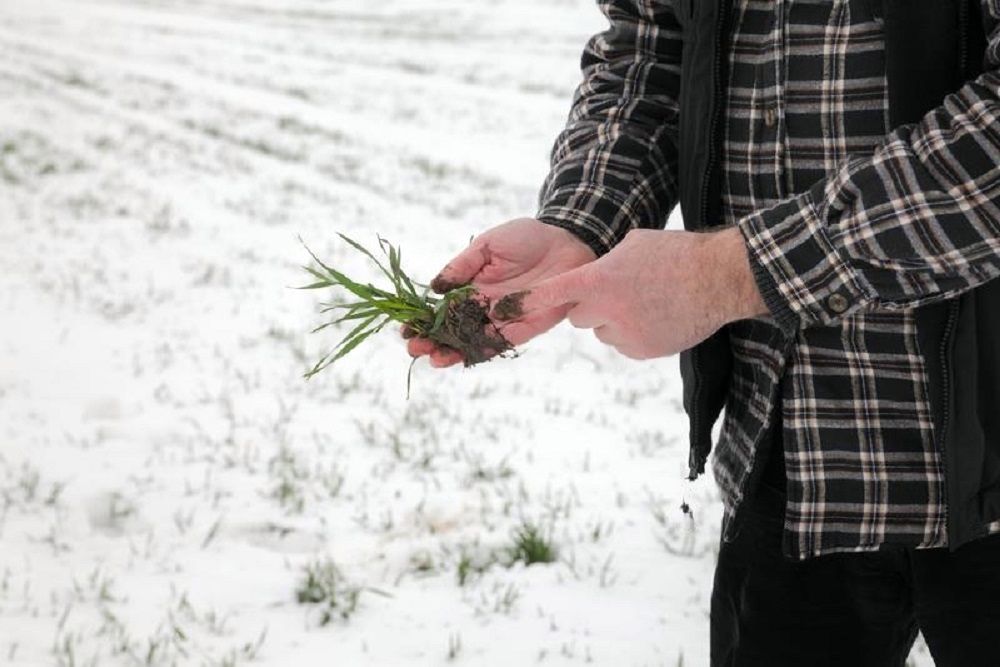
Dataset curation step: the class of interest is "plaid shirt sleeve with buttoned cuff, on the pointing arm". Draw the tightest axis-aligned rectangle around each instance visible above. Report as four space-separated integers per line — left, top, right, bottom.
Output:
737 0 1000 334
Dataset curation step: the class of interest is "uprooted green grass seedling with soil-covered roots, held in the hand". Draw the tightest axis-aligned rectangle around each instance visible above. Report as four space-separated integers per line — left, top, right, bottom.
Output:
298 234 513 393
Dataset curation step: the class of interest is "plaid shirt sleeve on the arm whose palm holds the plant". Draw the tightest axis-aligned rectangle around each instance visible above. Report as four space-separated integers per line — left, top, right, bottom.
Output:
536 0 682 256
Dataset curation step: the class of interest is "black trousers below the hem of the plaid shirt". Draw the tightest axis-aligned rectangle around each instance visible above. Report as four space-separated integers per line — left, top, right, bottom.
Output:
711 418 1000 667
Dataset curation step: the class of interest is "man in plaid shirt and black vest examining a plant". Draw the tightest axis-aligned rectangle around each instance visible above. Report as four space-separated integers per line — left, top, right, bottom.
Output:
409 0 1000 667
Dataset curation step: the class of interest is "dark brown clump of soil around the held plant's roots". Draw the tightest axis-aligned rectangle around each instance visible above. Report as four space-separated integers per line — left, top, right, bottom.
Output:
427 295 514 368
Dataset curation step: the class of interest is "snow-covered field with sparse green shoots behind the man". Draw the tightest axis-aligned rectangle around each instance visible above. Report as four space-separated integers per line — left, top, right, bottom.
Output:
0 0 926 666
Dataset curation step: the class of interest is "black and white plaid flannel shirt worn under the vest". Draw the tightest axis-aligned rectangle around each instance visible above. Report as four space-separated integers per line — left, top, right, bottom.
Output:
537 0 1000 559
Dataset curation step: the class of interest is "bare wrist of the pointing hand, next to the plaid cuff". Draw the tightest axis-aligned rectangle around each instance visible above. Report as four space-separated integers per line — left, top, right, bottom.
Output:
710 226 770 323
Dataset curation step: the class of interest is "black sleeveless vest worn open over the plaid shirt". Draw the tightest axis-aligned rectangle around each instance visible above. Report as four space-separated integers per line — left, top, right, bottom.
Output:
676 0 1000 549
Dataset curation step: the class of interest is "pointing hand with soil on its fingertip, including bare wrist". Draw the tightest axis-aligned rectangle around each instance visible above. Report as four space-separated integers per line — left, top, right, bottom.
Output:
493 227 768 359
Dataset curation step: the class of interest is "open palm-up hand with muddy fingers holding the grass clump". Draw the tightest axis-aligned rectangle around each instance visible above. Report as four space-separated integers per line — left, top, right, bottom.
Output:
404 218 597 368
